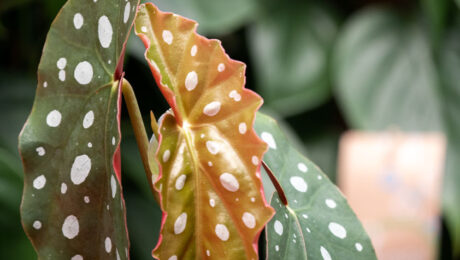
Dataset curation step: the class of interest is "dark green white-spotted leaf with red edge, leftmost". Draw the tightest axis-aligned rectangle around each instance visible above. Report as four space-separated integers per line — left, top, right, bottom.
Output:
19 0 138 260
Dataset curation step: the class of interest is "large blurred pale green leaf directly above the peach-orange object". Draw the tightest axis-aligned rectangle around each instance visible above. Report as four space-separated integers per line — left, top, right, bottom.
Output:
334 8 442 131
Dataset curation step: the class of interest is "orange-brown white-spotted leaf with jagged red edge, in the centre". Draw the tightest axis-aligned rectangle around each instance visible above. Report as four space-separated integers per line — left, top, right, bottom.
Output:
135 4 273 259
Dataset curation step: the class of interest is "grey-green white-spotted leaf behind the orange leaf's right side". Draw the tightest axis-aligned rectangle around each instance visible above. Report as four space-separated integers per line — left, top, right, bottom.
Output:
255 113 376 260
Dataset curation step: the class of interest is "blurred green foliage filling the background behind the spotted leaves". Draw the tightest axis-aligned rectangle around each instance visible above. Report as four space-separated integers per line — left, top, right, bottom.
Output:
0 0 460 260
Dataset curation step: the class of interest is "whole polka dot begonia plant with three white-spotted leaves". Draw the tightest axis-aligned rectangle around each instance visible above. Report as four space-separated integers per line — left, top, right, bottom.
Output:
19 0 375 260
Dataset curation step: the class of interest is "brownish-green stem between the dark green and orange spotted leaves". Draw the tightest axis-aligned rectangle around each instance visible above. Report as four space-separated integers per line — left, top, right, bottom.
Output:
122 78 158 195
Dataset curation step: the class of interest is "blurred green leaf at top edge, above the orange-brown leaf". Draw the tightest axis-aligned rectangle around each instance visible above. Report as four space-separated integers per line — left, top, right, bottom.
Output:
147 0 257 35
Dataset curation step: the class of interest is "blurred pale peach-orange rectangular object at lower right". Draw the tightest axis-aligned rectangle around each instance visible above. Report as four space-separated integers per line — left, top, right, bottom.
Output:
338 131 446 260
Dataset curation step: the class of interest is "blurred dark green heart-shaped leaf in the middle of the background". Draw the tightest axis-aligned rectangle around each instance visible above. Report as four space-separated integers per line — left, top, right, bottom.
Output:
248 3 337 115
